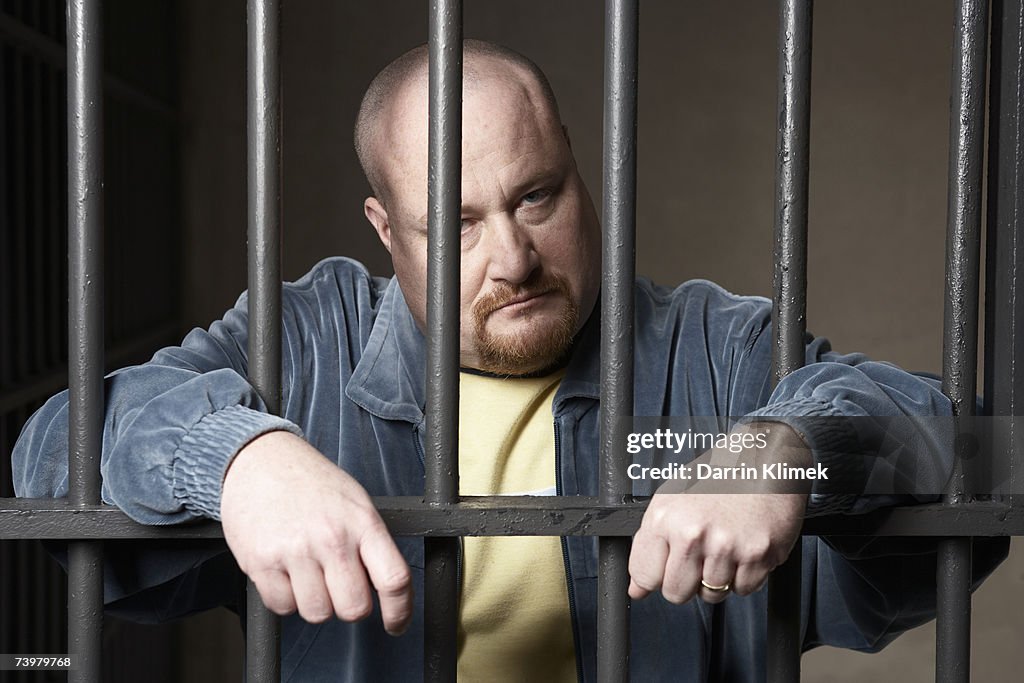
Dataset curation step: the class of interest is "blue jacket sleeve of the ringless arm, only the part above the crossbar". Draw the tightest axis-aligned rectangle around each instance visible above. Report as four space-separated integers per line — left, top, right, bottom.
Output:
12 302 299 524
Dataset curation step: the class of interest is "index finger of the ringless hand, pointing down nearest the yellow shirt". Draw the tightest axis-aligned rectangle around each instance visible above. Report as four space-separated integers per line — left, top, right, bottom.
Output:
359 522 413 636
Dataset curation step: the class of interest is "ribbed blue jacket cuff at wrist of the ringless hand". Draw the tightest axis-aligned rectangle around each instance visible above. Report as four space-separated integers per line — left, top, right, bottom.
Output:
173 405 302 520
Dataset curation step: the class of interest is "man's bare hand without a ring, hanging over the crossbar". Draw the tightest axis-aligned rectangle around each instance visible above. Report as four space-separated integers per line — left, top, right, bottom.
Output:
220 431 413 635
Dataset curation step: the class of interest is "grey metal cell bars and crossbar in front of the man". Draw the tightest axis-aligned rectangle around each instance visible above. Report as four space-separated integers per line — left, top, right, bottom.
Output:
0 0 1024 681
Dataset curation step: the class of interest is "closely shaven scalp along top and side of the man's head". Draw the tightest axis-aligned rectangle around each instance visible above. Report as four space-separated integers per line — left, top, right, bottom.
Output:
354 40 558 206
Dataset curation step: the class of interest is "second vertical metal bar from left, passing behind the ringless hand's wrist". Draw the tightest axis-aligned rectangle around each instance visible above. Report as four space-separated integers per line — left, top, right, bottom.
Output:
246 0 281 683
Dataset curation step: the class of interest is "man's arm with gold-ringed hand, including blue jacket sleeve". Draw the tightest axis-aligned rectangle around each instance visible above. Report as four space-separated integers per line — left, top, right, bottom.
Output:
630 287 1007 648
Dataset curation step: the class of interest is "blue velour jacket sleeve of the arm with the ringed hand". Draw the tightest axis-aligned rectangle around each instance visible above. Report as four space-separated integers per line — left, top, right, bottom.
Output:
692 282 1010 651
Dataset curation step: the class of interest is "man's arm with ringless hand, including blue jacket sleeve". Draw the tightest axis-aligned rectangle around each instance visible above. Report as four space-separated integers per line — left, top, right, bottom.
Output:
13 260 411 630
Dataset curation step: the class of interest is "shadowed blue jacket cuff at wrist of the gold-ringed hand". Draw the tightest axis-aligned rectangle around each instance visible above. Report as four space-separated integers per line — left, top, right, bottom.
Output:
744 398 867 517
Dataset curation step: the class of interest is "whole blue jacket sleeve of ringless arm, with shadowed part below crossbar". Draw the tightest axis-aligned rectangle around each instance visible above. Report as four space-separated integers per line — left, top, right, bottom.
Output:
12 299 299 623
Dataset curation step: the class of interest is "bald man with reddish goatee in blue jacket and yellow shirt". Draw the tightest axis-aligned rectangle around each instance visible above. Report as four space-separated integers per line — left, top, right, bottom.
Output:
14 41 1007 681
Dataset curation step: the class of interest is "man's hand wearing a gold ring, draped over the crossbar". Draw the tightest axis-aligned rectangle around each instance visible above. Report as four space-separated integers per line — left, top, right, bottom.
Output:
629 424 811 604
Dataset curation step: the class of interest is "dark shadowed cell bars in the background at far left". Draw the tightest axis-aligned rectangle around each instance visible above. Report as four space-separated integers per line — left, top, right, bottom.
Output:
0 0 180 683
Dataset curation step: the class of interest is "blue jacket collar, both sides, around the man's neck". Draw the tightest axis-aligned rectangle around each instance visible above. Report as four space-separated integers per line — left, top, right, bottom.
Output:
345 278 601 424
